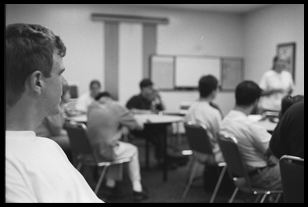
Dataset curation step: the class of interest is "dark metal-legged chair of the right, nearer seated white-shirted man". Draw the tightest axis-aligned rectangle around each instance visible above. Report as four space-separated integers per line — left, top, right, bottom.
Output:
218 133 282 203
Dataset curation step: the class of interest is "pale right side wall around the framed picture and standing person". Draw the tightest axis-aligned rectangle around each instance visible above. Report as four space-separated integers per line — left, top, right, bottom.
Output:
244 4 304 94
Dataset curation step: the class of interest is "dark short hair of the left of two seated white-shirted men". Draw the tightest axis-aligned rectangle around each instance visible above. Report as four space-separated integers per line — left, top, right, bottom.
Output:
198 75 218 98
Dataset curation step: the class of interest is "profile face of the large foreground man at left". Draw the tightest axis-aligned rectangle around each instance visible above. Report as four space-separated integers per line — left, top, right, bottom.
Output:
42 52 65 115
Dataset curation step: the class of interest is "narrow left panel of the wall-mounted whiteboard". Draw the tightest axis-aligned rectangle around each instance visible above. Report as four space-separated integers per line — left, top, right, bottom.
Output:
150 56 174 89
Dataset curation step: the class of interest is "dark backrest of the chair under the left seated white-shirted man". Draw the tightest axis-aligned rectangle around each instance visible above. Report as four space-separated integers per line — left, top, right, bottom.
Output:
184 123 213 155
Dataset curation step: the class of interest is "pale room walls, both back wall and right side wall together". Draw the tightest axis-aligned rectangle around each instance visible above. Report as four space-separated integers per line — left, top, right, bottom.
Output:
6 4 304 113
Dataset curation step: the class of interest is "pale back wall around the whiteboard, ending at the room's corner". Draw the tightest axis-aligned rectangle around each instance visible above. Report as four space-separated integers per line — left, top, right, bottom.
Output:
6 4 244 115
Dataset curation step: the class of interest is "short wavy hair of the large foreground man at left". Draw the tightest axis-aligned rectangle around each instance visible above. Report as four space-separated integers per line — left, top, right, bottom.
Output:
5 23 66 106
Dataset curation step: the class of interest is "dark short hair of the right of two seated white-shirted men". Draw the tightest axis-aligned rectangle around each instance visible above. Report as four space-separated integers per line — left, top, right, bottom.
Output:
235 81 262 106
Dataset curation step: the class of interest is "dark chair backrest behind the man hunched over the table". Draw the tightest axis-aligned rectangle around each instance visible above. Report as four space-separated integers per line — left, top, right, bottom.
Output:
64 123 92 155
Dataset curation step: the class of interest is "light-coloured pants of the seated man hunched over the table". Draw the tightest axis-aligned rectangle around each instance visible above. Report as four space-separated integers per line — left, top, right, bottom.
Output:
106 141 141 182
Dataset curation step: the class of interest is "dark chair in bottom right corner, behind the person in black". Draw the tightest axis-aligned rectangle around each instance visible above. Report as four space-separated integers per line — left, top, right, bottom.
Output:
279 155 304 203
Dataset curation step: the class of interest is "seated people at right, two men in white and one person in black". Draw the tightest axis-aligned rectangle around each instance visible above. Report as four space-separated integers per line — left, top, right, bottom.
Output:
186 75 304 190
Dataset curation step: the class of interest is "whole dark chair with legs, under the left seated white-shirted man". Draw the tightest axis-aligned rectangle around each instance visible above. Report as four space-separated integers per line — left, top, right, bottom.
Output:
182 123 226 203
